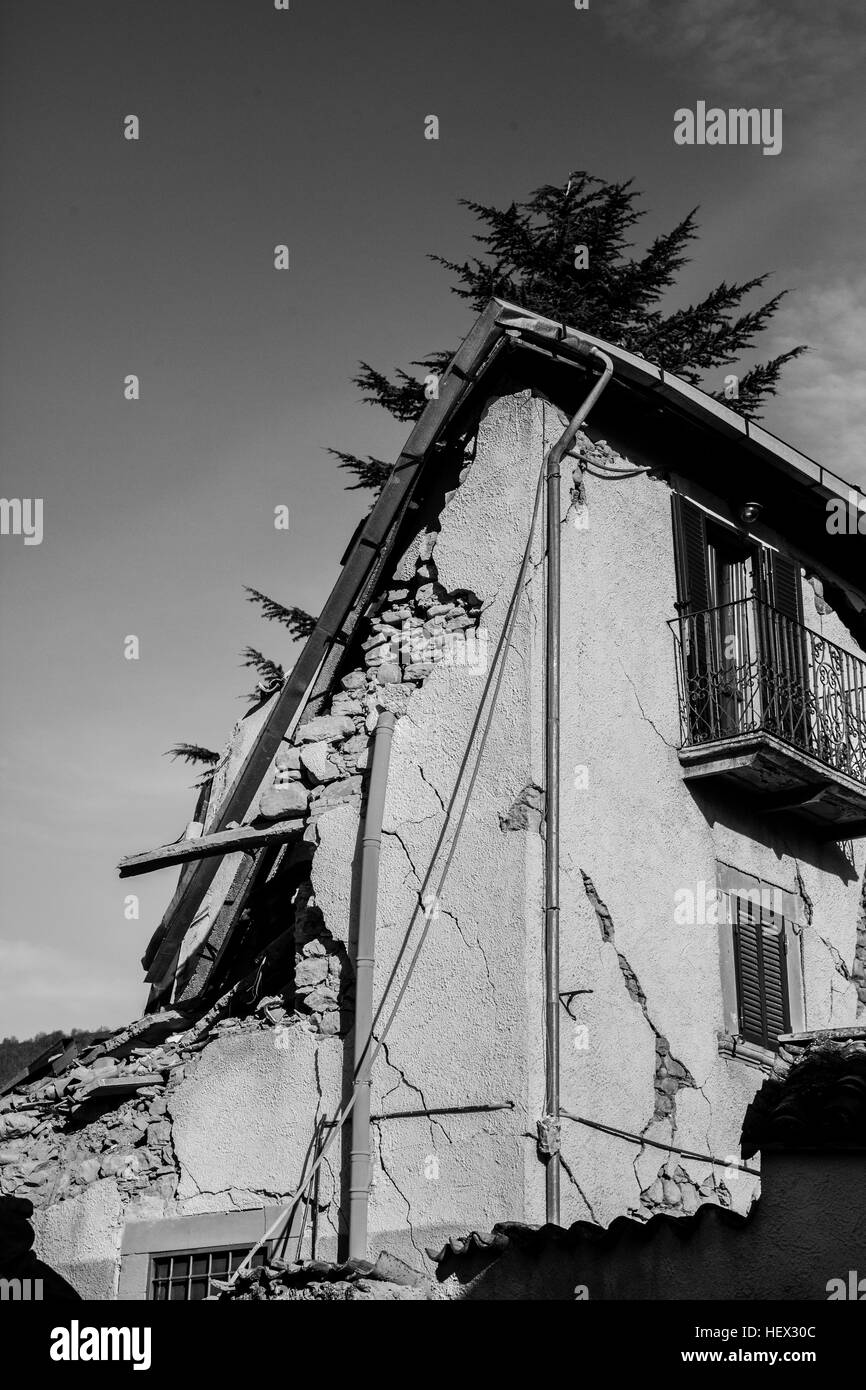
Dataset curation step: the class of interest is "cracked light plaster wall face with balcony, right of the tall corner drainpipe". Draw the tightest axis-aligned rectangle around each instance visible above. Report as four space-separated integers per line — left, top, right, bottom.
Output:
553 397 863 1225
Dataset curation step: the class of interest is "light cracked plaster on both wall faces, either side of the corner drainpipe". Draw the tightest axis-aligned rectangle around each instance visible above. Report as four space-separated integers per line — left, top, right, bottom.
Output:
314 393 863 1250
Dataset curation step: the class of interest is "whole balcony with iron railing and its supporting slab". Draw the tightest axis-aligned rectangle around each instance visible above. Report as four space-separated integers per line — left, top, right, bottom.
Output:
670 598 866 840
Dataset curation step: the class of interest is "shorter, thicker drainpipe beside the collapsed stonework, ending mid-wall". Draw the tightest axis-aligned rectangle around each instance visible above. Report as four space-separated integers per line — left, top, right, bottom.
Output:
349 710 395 1259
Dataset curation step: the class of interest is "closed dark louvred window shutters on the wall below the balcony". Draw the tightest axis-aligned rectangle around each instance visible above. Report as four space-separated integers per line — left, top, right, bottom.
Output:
731 895 791 1052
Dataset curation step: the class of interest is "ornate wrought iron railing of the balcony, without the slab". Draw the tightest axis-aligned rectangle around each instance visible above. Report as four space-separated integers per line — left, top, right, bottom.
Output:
670 598 866 784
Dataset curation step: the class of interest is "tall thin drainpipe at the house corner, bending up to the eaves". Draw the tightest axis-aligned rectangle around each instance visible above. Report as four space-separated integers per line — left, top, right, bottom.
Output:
538 343 613 1226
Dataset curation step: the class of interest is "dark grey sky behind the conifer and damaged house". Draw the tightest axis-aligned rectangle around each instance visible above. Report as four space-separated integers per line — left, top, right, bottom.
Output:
0 0 866 1036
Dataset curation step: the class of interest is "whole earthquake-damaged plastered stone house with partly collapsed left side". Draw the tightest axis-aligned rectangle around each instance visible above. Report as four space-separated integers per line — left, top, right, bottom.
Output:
0 300 866 1300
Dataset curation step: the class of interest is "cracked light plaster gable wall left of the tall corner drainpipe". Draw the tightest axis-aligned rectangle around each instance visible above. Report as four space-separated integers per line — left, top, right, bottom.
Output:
311 398 542 1259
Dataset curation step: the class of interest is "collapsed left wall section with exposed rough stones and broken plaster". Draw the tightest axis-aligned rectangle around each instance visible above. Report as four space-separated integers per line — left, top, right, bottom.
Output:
0 400 542 1297
